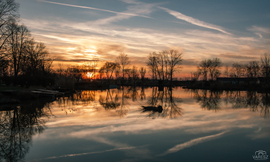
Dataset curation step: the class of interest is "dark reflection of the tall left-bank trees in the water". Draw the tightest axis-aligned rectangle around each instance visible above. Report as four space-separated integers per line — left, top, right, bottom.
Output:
0 100 52 161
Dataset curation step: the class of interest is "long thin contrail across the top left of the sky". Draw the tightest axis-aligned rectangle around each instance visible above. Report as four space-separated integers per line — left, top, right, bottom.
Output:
37 0 150 18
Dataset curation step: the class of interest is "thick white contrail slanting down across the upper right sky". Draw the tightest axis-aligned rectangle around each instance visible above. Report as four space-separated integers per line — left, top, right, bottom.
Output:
159 7 231 35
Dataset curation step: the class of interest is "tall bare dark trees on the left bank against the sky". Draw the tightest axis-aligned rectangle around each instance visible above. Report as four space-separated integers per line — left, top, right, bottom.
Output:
0 0 52 86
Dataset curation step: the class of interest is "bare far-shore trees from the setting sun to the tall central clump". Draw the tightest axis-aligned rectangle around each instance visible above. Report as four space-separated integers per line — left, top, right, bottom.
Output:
57 50 182 85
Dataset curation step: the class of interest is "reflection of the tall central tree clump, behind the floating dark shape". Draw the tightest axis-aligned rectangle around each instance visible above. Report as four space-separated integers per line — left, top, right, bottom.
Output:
142 87 182 119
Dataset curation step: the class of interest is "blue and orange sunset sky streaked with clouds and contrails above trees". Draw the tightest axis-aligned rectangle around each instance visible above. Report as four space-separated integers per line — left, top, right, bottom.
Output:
15 0 270 77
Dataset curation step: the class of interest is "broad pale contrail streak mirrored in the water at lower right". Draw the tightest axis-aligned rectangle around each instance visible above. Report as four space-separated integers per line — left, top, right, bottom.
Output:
160 131 227 156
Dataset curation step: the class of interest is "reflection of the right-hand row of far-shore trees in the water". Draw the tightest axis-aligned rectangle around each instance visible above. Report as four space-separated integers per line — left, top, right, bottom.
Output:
192 90 270 117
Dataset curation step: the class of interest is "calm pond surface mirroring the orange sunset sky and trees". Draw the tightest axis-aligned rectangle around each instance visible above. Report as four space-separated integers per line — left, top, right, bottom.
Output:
0 88 270 162
